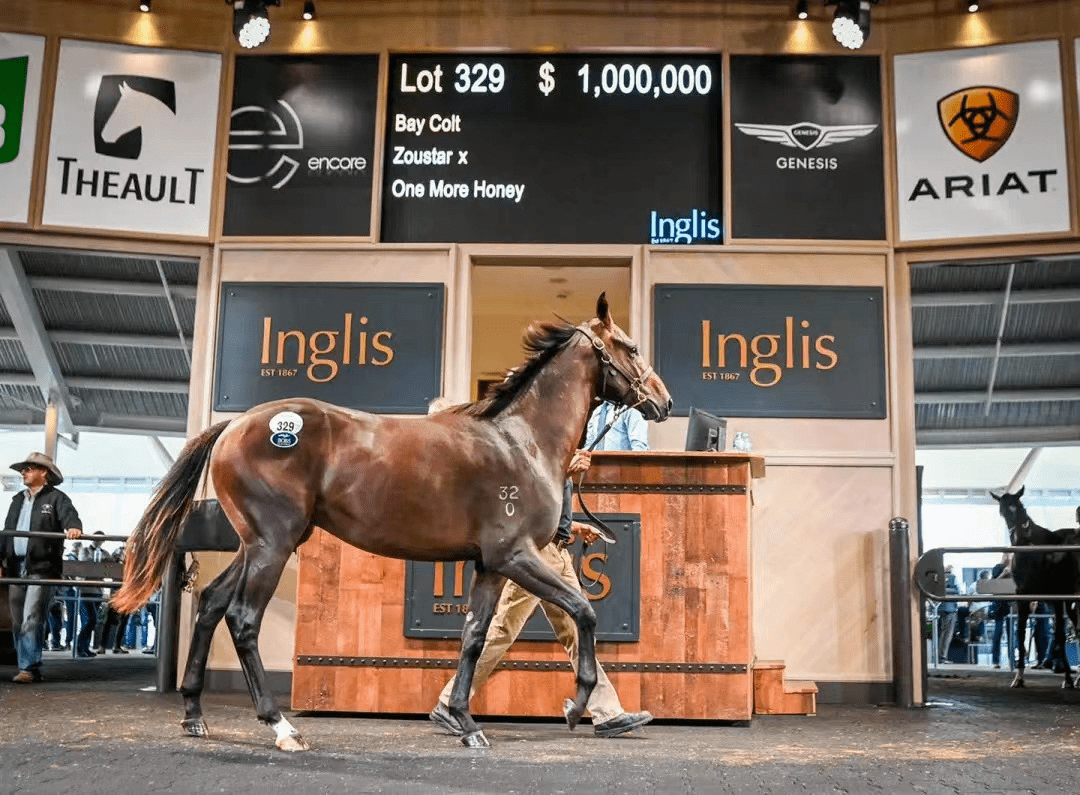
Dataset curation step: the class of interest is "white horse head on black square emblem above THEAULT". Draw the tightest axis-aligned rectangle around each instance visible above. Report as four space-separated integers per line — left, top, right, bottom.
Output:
94 75 176 160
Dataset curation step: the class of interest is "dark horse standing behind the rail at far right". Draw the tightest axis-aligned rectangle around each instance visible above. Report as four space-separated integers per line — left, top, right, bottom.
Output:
990 488 1080 687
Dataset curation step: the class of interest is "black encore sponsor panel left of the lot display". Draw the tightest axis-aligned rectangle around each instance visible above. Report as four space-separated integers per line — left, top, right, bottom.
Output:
224 55 379 235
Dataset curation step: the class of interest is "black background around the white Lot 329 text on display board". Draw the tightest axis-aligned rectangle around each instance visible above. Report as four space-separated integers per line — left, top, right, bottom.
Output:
381 54 723 243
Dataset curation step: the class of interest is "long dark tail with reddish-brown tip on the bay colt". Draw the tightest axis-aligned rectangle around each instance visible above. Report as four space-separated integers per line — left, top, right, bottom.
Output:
112 420 229 612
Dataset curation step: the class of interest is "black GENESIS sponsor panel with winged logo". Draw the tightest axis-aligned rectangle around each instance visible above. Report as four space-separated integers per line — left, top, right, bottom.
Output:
730 55 885 240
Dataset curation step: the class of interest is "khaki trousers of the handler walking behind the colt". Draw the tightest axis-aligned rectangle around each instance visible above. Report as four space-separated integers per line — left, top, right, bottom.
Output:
438 543 623 724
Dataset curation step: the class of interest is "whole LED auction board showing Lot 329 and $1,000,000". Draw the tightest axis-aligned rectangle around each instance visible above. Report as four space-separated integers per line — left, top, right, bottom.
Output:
381 54 723 244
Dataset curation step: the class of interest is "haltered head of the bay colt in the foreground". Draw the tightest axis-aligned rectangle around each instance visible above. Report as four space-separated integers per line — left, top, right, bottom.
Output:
578 293 672 422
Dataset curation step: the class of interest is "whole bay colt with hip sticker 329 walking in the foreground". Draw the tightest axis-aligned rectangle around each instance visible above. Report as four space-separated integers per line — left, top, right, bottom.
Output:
112 295 672 751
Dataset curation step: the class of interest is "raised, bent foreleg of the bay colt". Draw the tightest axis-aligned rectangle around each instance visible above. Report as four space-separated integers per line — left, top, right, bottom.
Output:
503 555 596 730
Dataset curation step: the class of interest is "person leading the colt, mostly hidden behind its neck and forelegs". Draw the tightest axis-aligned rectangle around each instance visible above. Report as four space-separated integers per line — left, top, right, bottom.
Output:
428 450 652 737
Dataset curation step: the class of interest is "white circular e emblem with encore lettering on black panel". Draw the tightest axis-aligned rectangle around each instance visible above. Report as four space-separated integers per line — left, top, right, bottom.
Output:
227 99 367 190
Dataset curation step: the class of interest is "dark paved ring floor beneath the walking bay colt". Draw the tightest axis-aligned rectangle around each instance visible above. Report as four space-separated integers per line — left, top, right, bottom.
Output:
0 655 1080 795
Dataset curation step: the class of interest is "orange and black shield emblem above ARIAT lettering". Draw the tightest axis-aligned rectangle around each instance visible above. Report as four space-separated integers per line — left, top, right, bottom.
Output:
937 85 1020 163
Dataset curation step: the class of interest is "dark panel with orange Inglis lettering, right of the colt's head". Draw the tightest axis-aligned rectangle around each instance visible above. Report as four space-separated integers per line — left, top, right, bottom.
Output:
652 284 886 419
